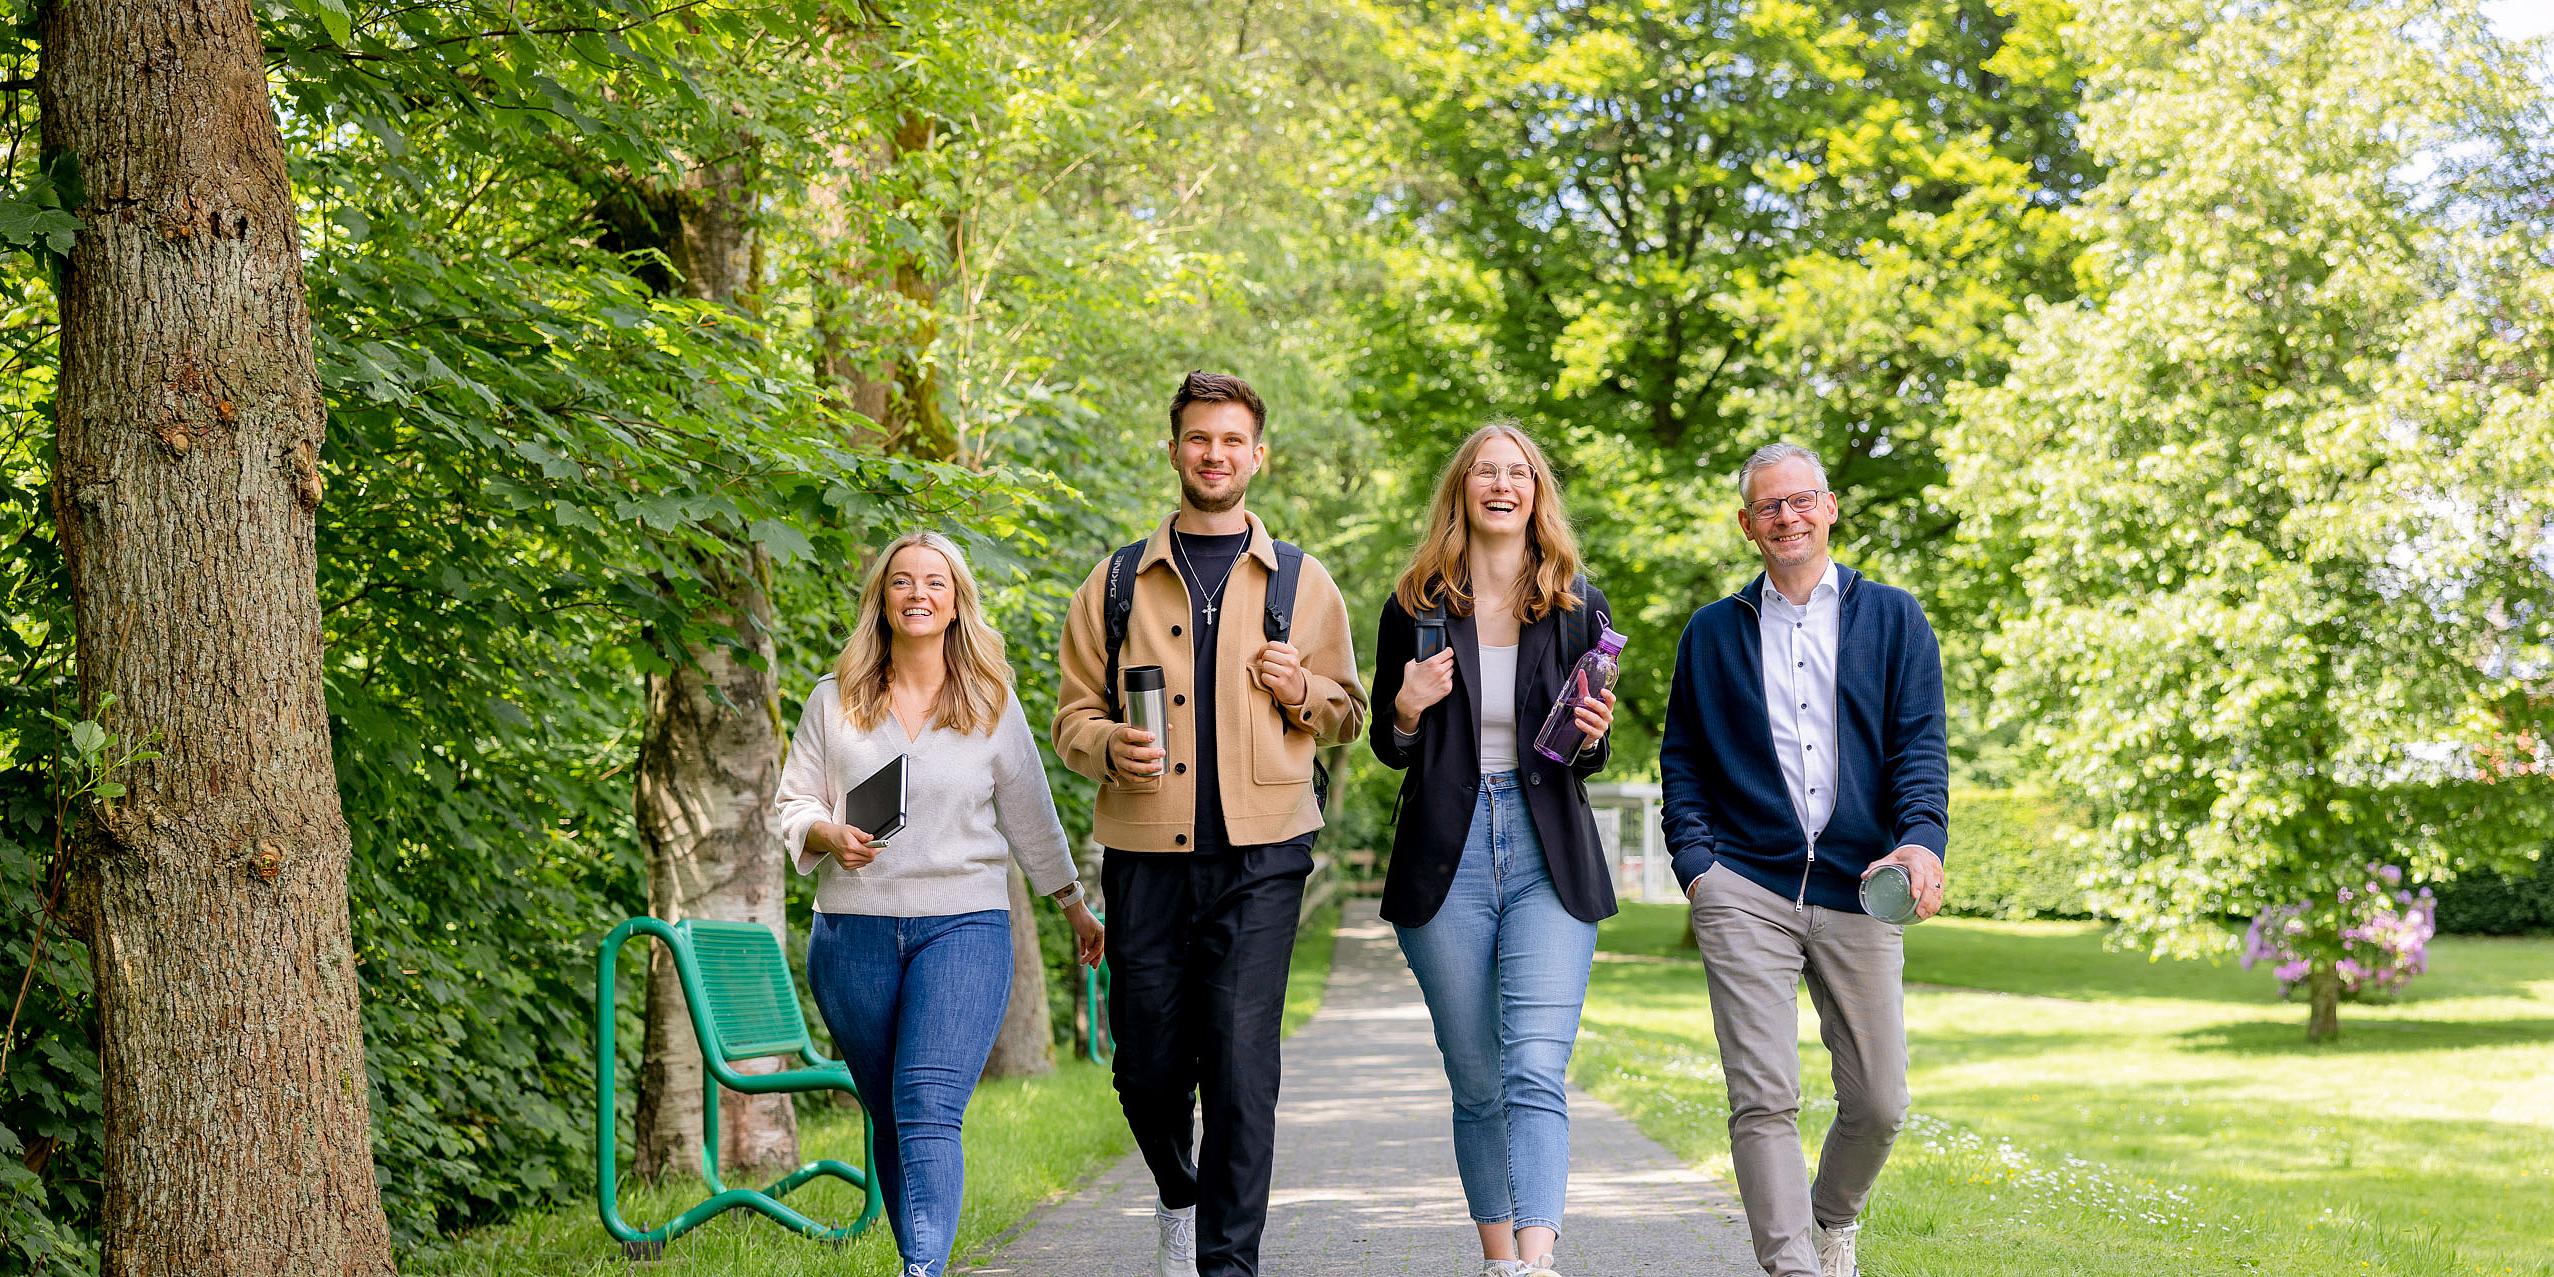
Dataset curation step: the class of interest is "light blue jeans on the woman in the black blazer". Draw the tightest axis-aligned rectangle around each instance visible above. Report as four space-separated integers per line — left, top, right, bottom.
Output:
1397 771 1596 1234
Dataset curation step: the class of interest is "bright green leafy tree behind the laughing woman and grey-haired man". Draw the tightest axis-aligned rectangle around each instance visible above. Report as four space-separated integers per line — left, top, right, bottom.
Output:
1359 0 2089 766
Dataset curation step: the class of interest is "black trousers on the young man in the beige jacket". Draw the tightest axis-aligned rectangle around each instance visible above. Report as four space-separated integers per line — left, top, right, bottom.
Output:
1101 835 1313 1277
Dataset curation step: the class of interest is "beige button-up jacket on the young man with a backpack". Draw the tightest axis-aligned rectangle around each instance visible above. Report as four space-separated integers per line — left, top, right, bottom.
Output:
1055 513 1366 850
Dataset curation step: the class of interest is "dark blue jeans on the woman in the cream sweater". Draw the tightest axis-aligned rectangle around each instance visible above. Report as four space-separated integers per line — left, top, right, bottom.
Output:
807 909 1011 1277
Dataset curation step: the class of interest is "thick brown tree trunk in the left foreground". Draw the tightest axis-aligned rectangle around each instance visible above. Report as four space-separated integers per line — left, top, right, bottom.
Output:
38 0 393 1277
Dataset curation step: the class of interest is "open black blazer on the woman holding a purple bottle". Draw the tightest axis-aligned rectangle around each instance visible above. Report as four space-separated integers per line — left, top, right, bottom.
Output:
1366 585 1614 927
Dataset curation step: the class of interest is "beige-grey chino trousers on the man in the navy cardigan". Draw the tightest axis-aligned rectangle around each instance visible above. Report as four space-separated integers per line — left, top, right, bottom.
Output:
1691 863 1908 1277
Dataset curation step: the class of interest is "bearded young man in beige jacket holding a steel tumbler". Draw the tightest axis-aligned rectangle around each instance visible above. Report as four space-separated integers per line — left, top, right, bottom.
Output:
1055 373 1366 1277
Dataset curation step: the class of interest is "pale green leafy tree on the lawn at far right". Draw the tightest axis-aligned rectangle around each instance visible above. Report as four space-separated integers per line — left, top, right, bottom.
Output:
1951 0 2554 1039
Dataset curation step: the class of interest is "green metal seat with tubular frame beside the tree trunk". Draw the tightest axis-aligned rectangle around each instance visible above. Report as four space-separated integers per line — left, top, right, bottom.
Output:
595 917 884 1259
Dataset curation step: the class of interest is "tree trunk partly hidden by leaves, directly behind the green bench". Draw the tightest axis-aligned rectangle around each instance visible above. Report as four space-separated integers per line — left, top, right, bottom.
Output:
636 161 797 1177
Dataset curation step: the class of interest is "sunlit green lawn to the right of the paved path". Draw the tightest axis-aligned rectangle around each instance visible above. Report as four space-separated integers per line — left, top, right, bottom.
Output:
1573 904 2554 1277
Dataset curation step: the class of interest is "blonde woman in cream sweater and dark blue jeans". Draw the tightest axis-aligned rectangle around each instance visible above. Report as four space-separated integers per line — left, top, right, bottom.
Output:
779 531 1101 1277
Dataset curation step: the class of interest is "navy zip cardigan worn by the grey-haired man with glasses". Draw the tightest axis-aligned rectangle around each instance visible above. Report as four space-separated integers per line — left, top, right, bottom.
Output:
1658 564 1951 914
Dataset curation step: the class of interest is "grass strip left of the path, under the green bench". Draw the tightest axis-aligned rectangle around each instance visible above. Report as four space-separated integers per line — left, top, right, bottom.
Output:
401 904 1338 1277
